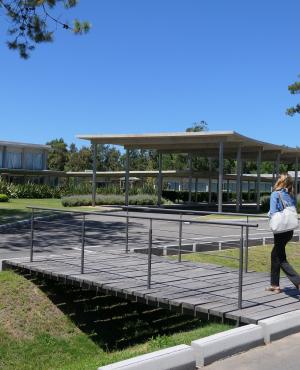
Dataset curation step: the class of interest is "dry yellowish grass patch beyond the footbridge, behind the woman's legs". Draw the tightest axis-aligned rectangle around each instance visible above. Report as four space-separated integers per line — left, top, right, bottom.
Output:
178 243 300 272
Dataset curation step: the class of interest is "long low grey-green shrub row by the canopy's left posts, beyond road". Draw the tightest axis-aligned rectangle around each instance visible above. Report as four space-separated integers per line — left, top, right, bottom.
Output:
62 194 167 207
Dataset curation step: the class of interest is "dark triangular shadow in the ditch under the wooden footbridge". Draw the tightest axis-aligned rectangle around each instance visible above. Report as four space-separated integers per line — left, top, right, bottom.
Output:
19 271 225 351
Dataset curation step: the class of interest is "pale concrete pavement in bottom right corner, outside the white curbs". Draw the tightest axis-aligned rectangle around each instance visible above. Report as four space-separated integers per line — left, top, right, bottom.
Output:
204 333 300 370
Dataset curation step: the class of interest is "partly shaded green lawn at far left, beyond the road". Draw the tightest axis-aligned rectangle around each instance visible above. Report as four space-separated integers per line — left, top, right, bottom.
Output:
0 199 110 224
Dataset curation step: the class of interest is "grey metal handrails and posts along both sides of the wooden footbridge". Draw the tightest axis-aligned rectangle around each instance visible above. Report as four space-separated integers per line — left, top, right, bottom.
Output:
27 206 258 309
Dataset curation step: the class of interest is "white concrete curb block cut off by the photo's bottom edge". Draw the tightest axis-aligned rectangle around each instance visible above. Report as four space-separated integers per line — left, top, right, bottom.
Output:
98 344 196 370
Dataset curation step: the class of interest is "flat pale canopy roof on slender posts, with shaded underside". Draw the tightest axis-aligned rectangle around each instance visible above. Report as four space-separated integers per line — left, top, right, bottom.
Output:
77 131 300 162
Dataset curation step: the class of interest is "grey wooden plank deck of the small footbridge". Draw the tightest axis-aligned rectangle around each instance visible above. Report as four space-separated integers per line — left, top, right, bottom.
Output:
3 250 300 323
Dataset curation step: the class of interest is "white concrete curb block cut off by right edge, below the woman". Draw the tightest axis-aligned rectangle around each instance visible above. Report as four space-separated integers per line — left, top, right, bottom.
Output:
258 310 300 344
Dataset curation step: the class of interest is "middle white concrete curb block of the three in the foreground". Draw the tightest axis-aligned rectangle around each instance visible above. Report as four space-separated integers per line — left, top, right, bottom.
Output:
191 324 264 366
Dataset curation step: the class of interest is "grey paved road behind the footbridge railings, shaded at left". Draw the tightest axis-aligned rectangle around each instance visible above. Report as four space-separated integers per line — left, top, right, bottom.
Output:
0 212 272 260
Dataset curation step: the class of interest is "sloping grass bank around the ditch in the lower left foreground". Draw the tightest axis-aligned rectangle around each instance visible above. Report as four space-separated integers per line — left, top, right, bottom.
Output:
0 271 231 370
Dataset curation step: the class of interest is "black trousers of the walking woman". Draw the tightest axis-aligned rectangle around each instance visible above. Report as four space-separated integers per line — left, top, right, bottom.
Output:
271 231 300 288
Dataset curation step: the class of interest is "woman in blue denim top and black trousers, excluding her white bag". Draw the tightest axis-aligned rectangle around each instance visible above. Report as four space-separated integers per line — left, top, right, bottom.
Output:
267 174 300 293
